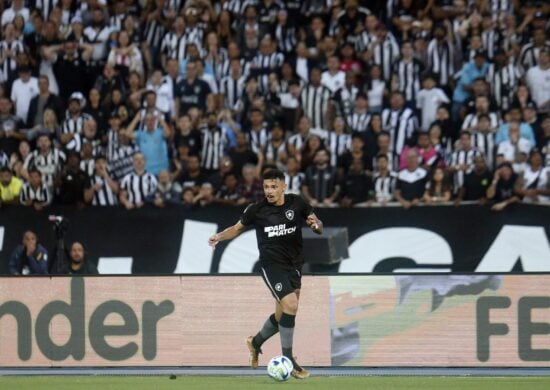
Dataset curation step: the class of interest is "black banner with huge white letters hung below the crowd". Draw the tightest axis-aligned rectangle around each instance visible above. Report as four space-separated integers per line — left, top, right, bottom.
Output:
0 204 550 275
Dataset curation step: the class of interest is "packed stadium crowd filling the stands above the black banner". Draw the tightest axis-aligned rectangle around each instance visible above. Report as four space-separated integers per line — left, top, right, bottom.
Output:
0 0 550 210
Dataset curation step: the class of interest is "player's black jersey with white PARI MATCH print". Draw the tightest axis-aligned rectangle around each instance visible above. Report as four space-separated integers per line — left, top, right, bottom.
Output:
241 194 313 268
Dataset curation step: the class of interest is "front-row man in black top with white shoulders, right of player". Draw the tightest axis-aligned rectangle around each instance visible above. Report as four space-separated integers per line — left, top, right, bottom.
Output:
395 149 427 209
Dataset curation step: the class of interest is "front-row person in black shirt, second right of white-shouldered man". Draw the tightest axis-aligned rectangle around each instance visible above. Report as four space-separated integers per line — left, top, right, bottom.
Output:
455 154 493 206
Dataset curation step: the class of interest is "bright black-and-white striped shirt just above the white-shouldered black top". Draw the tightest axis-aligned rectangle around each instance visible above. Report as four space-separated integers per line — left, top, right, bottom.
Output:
382 108 418 155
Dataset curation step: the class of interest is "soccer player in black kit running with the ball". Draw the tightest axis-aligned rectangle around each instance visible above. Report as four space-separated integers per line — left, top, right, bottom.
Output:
208 169 323 379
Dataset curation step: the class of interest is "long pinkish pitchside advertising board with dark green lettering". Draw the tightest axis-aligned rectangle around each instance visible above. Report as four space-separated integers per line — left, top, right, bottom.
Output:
0 273 550 367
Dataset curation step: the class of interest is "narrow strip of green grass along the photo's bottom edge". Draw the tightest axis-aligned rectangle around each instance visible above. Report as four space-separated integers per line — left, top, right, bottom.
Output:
0 375 550 390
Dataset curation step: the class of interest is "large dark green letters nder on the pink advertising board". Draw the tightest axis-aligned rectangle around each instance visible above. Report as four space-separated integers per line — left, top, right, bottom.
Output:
0 277 174 361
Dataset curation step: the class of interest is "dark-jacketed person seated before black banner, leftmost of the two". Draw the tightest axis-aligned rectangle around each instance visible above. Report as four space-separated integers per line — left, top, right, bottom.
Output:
9 230 48 275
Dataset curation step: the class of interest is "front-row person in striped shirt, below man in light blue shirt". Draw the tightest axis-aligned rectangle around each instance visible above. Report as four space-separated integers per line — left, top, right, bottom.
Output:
119 153 158 210
